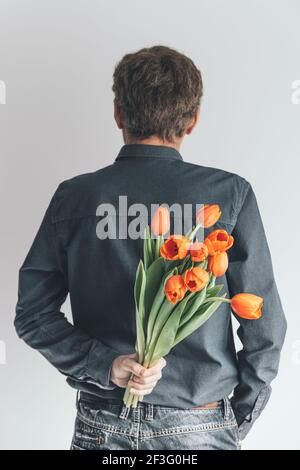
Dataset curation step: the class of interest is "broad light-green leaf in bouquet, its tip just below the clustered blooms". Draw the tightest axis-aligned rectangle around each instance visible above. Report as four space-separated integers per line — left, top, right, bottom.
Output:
150 295 189 364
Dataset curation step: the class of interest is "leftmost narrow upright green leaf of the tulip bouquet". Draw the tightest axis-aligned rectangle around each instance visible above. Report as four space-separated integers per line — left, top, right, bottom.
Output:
134 260 146 362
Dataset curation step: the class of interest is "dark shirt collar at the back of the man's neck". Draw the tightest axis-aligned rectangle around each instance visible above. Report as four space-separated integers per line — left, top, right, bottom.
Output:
116 144 183 161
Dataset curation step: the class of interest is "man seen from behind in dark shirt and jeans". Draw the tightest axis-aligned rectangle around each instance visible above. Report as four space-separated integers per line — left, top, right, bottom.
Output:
15 46 286 450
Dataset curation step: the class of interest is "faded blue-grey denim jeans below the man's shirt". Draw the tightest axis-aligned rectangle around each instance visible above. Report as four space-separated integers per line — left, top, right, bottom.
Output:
71 394 240 451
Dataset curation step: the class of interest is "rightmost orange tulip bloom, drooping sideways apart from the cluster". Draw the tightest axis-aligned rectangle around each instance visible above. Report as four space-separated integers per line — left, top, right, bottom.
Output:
231 293 264 320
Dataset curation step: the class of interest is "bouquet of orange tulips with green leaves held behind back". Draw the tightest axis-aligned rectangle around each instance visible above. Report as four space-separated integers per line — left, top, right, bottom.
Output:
123 204 263 408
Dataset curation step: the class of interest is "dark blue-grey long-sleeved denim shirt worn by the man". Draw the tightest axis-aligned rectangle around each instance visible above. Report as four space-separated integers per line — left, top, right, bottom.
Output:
15 144 286 439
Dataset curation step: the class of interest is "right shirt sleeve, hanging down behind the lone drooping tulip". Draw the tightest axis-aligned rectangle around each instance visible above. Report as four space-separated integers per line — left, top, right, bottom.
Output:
226 180 286 439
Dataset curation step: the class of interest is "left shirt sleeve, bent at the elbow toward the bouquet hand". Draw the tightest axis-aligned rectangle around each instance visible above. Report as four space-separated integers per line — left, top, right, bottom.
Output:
14 186 119 390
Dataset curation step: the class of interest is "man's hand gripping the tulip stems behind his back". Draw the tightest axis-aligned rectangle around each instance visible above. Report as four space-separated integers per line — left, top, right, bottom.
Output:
110 354 167 396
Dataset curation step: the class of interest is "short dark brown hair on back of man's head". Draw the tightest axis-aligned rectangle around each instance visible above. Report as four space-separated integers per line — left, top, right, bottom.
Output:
112 45 203 142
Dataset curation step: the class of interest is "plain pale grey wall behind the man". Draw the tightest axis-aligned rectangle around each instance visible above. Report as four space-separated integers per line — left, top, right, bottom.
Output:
0 0 300 449
